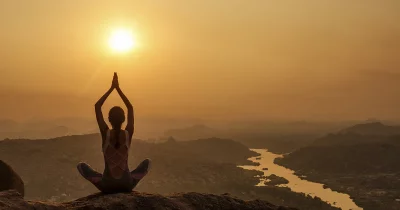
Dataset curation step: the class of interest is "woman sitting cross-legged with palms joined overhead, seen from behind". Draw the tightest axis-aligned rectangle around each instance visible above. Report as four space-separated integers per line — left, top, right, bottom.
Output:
77 73 150 193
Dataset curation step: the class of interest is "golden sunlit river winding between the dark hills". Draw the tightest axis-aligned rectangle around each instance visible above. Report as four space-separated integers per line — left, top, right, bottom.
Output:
239 149 362 210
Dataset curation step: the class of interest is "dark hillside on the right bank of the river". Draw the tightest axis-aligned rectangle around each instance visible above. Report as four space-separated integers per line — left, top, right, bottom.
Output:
275 123 400 210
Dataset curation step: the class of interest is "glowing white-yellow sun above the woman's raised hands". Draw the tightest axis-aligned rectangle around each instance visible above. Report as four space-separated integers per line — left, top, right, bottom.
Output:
108 28 137 53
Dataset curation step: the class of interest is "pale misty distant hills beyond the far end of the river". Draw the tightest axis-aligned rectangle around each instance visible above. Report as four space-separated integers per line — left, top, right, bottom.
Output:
164 121 356 154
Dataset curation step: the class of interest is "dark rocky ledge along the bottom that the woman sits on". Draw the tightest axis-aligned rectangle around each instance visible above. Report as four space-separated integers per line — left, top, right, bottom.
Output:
0 191 295 210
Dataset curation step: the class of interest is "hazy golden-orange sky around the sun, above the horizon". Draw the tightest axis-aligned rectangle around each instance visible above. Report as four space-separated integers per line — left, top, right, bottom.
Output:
0 0 400 120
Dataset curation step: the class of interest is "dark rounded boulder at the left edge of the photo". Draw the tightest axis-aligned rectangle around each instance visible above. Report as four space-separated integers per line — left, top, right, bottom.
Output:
0 160 24 196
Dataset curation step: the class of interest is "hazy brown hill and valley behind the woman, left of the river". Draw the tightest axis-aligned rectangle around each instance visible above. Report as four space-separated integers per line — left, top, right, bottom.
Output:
0 134 335 210
